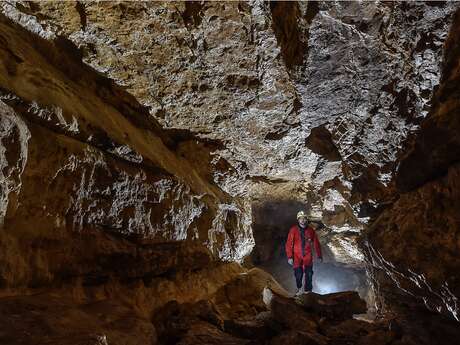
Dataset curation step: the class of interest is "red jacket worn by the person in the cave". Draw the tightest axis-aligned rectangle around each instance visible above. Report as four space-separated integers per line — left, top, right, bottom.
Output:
286 225 322 268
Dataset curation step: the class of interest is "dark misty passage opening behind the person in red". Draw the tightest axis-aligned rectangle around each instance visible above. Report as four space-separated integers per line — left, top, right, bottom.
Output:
251 200 371 305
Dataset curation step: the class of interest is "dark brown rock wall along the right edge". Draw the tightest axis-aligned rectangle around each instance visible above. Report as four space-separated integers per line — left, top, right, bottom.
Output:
365 8 460 321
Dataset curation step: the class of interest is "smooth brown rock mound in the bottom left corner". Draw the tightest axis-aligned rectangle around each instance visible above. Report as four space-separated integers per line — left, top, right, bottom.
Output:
0 294 156 345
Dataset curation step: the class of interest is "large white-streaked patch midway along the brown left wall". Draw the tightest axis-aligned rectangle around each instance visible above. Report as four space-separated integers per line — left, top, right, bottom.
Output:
52 147 204 241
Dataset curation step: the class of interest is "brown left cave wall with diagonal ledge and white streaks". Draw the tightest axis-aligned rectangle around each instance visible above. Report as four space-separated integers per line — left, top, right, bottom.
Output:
0 8 260 345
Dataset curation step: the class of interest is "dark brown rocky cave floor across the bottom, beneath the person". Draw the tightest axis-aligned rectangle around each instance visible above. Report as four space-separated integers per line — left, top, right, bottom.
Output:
0 268 459 345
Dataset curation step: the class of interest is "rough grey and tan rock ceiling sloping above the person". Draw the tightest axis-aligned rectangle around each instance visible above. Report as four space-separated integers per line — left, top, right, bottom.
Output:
2 1 457 236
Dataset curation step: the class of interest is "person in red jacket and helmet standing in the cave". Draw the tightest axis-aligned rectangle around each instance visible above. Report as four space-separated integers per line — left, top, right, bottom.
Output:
286 211 323 296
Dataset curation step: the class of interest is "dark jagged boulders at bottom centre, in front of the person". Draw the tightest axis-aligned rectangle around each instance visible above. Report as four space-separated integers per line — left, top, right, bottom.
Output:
153 286 408 345
